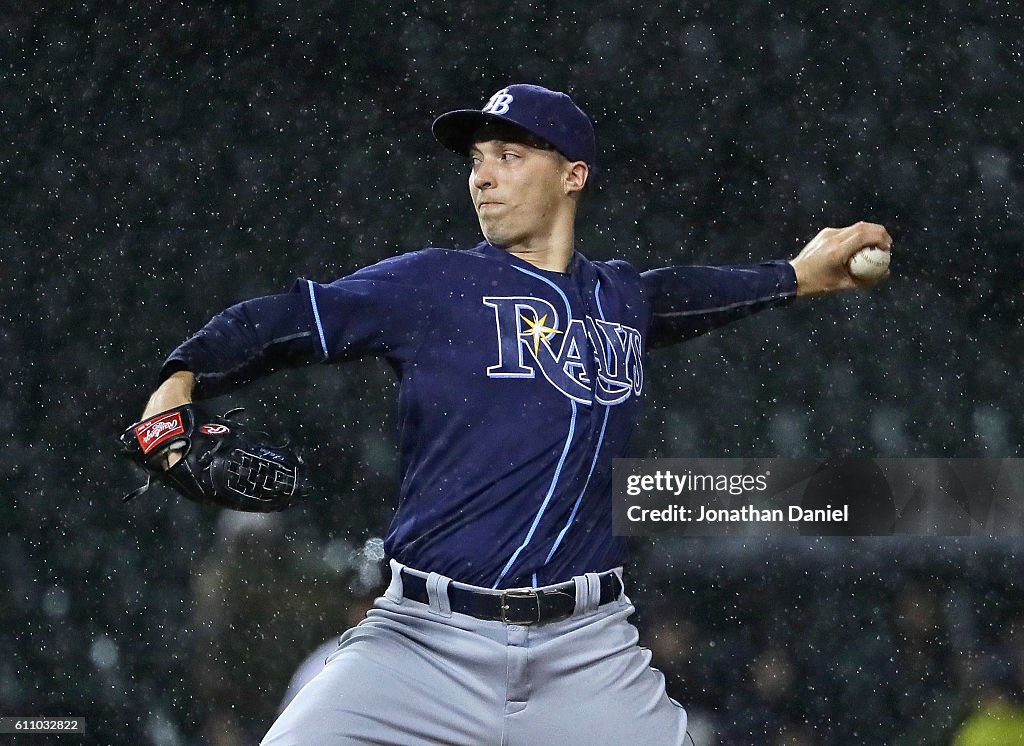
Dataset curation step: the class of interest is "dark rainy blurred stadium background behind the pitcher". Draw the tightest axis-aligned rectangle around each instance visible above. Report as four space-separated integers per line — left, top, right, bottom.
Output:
6 0 1024 746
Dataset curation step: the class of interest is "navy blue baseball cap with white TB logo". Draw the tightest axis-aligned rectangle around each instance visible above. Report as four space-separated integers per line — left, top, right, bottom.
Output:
431 83 597 169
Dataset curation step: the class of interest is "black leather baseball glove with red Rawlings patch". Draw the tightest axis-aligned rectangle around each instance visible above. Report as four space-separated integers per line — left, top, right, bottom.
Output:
120 404 308 513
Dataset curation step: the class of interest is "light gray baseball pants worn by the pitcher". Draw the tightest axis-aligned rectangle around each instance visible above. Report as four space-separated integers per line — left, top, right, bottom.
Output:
262 560 686 746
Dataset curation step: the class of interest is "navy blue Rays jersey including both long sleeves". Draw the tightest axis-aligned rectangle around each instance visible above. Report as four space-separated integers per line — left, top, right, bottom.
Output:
164 243 797 587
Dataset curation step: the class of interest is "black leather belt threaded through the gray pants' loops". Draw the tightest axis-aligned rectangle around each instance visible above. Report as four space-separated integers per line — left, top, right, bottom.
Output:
401 568 623 624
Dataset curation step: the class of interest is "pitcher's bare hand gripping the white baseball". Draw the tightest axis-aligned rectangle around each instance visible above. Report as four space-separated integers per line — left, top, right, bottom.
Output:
790 223 893 296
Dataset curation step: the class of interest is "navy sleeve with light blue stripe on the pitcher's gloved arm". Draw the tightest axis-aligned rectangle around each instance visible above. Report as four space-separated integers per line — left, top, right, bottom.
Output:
161 250 429 398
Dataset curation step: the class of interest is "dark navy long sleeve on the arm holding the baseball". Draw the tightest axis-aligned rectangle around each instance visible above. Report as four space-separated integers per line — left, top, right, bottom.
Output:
640 260 797 348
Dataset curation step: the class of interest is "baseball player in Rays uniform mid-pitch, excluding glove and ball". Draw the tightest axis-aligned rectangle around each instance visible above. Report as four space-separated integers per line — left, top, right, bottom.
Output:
134 84 891 746
